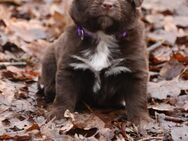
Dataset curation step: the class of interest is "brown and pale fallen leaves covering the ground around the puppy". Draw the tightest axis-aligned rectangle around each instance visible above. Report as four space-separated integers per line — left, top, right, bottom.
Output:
0 0 188 141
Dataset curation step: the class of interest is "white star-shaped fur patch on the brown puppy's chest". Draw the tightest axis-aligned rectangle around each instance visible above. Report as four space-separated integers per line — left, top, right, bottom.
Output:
70 32 130 93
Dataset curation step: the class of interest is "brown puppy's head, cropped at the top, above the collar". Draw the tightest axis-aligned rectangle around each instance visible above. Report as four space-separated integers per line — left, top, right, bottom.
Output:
70 0 143 32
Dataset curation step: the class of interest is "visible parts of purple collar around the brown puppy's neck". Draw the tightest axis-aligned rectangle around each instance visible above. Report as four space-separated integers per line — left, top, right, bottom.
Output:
76 26 127 40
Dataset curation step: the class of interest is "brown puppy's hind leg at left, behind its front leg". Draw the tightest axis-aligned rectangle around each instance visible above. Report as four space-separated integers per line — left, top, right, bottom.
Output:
41 47 57 103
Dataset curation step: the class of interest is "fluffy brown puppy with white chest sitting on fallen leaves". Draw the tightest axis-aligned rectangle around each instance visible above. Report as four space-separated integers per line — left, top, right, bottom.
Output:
42 0 148 124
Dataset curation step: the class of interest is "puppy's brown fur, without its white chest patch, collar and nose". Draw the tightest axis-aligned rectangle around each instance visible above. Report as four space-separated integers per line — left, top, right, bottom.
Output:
42 0 148 124
